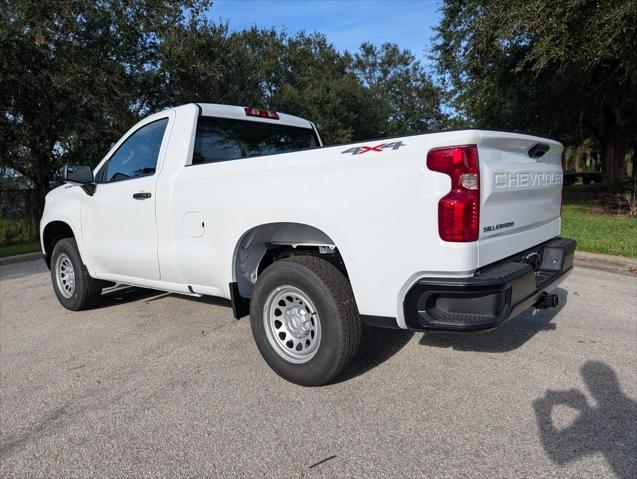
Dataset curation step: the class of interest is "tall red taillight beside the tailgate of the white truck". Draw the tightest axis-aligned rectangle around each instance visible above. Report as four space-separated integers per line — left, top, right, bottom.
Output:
427 145 480 242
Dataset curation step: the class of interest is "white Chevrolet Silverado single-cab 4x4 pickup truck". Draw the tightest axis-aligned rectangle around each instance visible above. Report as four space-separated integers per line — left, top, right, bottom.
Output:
40 104 575 385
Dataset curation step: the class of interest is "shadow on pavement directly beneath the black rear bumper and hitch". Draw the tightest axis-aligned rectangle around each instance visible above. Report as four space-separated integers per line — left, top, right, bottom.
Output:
420 288 568 353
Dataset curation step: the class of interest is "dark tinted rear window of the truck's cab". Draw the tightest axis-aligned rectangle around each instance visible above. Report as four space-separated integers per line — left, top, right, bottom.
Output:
192 116 318 165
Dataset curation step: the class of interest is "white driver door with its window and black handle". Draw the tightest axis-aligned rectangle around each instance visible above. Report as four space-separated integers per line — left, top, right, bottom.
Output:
82 117 169 280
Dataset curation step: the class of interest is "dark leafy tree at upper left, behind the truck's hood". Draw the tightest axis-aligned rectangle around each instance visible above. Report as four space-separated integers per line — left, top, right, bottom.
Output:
0 0 208 229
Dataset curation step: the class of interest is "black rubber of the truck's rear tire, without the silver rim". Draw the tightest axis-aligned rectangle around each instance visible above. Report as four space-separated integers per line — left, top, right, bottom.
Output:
250 256 362 386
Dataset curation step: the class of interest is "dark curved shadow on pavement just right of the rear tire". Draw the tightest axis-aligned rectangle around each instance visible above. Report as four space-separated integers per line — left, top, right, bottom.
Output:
334 327 414 384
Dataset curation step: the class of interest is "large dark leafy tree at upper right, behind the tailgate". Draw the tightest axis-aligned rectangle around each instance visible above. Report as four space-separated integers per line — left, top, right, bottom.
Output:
434 0 637 184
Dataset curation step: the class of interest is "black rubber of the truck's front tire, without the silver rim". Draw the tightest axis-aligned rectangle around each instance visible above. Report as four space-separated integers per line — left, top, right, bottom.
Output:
51 238 102 311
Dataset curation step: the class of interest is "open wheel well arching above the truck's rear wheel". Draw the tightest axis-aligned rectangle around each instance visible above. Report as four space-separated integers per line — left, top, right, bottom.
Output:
233 223 347 298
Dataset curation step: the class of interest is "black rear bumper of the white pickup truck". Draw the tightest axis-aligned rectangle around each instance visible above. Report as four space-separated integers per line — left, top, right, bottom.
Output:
403 238 575 331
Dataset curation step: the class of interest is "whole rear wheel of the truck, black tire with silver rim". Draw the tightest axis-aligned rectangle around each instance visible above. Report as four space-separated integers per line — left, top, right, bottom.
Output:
250 256 361 386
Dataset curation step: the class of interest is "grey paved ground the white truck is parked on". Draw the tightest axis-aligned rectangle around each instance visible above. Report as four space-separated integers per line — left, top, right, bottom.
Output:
0 261 637 478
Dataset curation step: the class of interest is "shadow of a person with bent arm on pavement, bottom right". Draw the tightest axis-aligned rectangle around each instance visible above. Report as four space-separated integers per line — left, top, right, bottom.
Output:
533 361 637 478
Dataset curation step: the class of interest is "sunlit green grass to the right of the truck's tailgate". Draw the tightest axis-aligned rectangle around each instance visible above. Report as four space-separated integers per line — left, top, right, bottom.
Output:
562 185 637 258
